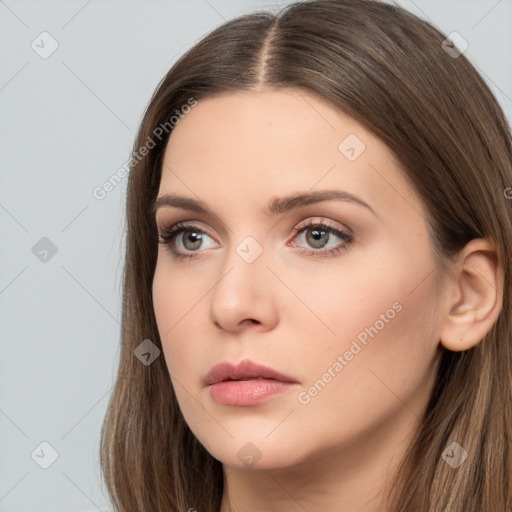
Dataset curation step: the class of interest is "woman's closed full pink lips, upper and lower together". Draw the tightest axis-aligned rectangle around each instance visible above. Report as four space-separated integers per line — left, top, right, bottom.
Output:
204 359 299 406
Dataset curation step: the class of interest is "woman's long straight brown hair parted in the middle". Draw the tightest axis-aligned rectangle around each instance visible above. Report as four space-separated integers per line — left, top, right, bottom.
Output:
100 0 512 512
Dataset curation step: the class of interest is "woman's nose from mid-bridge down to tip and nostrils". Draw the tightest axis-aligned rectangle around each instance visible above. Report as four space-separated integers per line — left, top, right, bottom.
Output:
210 249 278 332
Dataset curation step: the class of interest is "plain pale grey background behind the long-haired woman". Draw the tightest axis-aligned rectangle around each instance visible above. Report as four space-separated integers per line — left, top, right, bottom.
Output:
0 0 512 512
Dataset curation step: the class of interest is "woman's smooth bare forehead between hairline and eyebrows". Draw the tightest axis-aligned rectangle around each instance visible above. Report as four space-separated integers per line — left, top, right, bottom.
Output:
160 89 424 220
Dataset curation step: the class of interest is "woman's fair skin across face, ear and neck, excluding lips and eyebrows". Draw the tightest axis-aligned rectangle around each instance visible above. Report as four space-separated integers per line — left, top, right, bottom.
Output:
153 89 501 512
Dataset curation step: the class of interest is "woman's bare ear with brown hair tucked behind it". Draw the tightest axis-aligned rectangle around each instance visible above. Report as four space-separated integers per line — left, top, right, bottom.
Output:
440 238 503 352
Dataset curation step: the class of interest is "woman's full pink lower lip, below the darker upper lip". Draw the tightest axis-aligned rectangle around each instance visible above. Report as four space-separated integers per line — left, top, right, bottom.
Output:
210 379 297 406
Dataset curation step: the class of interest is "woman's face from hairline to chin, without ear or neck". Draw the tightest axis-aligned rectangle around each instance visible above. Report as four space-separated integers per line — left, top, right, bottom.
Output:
153 89 443 468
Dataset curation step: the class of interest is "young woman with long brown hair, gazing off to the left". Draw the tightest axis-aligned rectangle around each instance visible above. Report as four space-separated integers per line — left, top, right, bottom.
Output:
101 0 512 512
